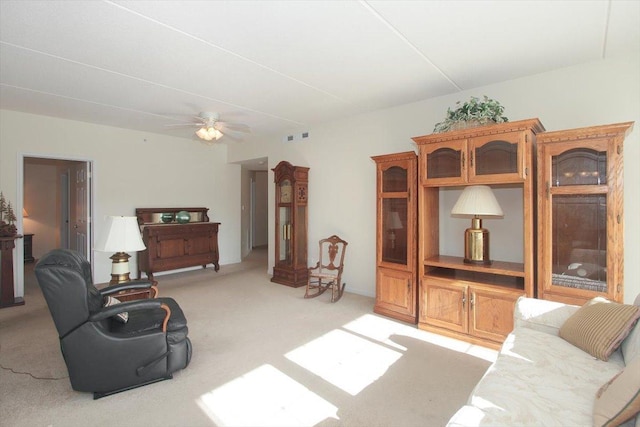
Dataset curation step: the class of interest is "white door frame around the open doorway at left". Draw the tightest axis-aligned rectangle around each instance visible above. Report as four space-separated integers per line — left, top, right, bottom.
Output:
14 153 95 298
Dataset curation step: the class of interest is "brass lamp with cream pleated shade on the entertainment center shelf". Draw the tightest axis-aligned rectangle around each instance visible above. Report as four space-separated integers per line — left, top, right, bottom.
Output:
451 185 503 265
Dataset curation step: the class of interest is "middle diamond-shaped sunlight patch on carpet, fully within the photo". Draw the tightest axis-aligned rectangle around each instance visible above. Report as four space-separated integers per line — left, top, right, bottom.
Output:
285 329 402 396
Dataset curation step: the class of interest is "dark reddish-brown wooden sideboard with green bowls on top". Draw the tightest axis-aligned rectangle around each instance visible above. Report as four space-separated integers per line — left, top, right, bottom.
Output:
136 208 220 280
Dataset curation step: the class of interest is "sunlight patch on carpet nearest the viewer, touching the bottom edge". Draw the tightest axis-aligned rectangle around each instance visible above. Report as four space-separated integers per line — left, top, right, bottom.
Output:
197 365 338 427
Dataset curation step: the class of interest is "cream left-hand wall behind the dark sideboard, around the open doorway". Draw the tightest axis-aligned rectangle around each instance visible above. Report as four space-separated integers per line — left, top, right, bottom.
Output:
0 110 241 296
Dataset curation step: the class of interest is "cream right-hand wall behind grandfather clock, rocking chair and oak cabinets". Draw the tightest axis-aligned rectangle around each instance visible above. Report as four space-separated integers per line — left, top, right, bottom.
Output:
229 56 640 302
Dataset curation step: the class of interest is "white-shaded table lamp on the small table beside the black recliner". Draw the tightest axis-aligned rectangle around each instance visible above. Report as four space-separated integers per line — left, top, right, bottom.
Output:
96 216 146 285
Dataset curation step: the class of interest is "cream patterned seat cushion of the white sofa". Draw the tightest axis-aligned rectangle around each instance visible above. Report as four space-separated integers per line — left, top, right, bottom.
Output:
449 327 624 426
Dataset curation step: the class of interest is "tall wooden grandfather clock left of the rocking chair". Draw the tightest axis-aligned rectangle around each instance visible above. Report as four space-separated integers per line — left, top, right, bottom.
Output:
271 161 309 288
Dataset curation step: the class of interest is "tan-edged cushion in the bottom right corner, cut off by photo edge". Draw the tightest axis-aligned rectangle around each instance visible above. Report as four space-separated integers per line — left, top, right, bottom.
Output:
593 358 640 427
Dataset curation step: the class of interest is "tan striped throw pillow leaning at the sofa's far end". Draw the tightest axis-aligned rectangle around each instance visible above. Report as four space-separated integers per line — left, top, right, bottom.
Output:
559 298 640 361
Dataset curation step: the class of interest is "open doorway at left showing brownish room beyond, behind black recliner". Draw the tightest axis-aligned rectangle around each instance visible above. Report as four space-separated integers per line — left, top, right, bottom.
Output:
16 155 93 296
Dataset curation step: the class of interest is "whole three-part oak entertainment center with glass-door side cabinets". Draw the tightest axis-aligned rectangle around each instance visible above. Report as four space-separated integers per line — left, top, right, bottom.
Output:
373 118 634 348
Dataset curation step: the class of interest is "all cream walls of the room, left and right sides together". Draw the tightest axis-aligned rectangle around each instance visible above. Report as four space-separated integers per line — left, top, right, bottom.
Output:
0 56 640 301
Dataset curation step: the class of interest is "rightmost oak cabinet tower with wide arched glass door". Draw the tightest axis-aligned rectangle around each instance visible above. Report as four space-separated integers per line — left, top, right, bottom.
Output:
536 118 633 305
